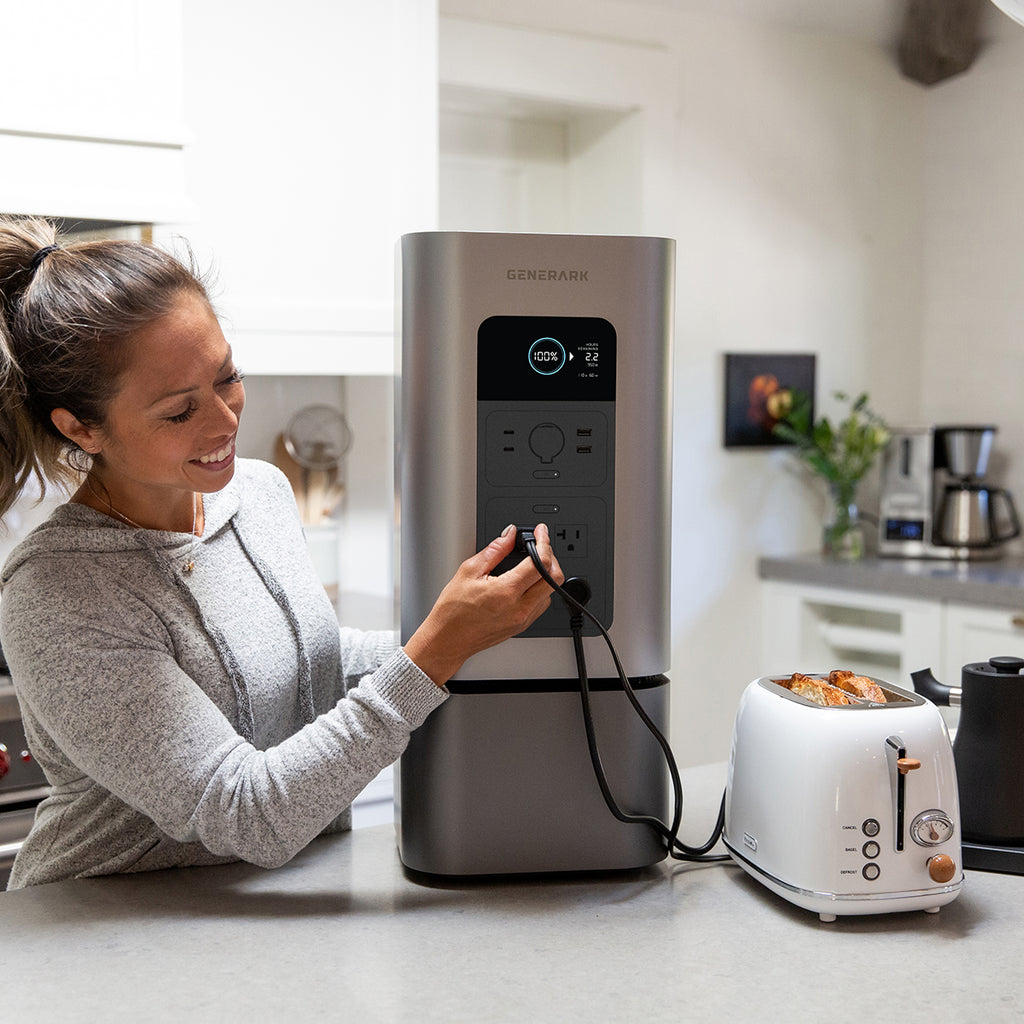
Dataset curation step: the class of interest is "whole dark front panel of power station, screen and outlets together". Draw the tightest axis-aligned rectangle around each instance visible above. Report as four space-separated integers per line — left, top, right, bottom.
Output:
476 315 616 637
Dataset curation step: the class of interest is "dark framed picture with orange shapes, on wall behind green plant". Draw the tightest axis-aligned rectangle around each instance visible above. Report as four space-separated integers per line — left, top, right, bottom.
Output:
725 352 815 447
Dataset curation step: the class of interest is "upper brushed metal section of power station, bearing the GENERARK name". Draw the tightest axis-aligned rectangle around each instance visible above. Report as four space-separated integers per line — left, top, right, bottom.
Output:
395 231 675 680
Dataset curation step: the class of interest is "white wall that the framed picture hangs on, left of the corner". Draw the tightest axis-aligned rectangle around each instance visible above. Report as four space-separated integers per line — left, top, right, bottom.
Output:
441 0 927 764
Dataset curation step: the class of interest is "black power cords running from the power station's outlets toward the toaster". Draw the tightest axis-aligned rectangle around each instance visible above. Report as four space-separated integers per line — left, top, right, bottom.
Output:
516 528 730 861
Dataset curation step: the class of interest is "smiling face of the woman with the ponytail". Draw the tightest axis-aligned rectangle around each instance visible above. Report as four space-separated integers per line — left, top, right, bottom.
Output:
84 293 246 520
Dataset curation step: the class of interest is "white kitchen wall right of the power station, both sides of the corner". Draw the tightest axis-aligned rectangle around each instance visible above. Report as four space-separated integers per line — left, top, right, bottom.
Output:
673 4 1024 761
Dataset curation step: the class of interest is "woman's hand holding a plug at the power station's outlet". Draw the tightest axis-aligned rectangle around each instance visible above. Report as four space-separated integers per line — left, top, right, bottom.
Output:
404 523 562 686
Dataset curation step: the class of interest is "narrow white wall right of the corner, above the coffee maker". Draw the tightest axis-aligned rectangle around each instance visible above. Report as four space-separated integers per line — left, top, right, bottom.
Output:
921 20 1024 516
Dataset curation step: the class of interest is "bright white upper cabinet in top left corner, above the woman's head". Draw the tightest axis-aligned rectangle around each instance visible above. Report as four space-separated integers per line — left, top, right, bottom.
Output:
0 0 194 223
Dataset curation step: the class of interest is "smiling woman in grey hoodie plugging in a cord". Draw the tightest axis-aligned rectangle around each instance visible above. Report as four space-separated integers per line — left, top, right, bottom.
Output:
0 219 560 889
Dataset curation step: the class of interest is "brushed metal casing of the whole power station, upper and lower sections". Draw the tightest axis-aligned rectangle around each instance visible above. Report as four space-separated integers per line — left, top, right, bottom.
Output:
395 232 675 876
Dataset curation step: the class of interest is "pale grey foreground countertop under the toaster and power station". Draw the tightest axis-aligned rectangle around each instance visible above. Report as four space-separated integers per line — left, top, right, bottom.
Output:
0 765 1024 1024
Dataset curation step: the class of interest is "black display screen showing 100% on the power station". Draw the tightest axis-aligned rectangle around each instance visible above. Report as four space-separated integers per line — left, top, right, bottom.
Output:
476 316 615 401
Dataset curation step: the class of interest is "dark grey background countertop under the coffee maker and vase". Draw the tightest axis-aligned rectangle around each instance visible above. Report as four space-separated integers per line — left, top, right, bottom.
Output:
758 554 1024 610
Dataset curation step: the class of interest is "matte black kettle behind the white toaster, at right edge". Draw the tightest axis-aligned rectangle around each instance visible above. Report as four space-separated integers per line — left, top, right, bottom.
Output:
910 657 1024 847
